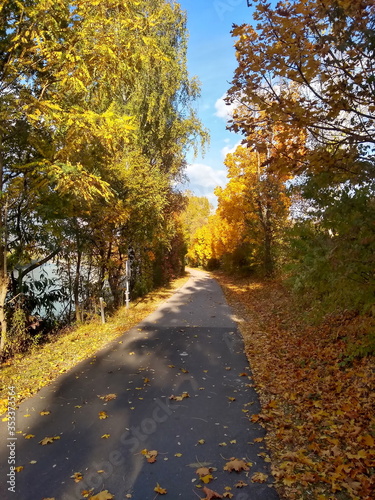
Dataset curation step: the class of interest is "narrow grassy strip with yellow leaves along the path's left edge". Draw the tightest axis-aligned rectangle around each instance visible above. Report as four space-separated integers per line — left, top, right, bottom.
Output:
0 275 189 415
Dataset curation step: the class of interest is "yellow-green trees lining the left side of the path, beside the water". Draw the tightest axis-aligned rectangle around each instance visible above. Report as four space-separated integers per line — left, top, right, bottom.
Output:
0 0 207 354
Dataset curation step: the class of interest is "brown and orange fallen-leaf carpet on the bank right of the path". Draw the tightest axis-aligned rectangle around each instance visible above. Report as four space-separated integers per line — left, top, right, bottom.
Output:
213 273 375 500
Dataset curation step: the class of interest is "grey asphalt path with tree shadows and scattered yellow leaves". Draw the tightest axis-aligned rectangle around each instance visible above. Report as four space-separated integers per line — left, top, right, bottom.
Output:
0 270 278 500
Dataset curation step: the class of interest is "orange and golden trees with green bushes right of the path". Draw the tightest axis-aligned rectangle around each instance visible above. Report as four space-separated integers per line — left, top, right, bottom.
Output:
188 0 375 320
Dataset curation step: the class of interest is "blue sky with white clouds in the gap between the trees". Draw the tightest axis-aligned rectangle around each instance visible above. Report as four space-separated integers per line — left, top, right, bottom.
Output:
179 0 252 205
